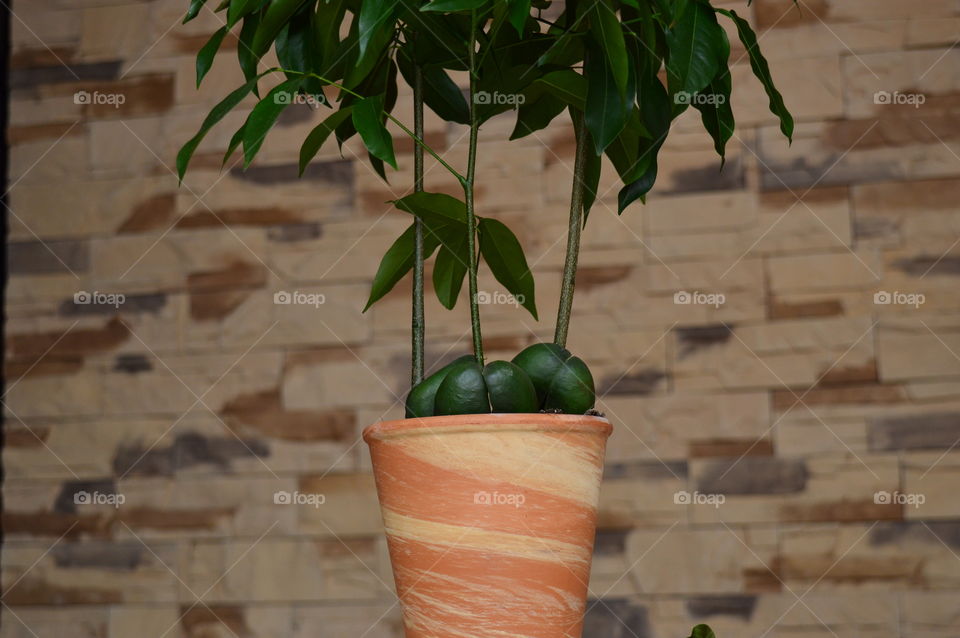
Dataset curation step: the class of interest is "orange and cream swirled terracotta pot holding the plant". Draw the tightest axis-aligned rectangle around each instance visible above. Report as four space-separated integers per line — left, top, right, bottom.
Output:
363 414 612 638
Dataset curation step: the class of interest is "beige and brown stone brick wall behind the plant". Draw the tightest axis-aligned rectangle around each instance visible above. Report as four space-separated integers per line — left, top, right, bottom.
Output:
0 0 960 638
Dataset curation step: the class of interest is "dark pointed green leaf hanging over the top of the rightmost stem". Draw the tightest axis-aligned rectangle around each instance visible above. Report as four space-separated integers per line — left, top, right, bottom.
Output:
584 46 633 155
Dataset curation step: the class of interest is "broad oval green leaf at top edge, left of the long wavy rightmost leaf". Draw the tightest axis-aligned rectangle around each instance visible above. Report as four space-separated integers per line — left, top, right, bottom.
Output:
667 1 723 95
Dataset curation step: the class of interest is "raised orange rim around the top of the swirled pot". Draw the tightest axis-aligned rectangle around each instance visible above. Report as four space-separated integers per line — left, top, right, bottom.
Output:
363 413 613 443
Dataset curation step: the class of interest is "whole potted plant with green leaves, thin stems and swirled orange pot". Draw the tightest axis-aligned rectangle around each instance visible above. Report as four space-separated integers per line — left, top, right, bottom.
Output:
177 0 793 638
